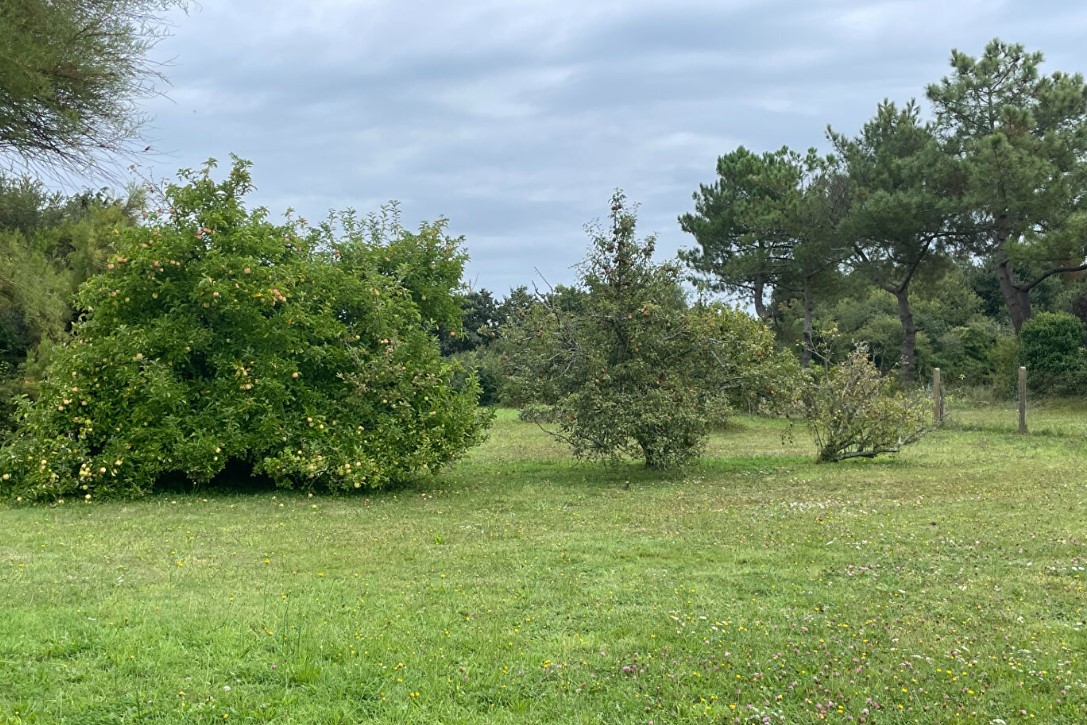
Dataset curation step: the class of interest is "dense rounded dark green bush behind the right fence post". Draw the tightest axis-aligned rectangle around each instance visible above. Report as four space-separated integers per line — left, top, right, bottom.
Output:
1019 312 1087 396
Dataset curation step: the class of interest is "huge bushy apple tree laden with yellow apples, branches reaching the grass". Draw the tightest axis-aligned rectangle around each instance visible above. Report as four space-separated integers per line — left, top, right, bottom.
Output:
0 161 487 500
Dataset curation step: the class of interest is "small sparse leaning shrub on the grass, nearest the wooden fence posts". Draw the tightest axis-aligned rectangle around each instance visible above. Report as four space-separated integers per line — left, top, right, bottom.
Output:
804 345 932 463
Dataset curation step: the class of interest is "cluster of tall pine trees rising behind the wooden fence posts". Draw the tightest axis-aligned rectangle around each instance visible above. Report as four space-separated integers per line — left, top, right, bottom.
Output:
679 39 1087 389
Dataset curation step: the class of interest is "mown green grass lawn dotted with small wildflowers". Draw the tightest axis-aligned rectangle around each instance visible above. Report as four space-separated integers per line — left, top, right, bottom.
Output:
0 407 1087 725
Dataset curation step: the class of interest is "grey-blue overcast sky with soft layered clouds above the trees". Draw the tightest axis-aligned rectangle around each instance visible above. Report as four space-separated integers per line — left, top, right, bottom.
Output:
143 0 1087 296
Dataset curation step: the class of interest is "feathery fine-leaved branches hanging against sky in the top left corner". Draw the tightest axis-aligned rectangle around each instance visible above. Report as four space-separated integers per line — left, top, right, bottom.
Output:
0 0 187 175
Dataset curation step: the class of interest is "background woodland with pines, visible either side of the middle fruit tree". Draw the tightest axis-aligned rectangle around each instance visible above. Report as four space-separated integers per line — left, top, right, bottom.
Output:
443 40 1087 400
